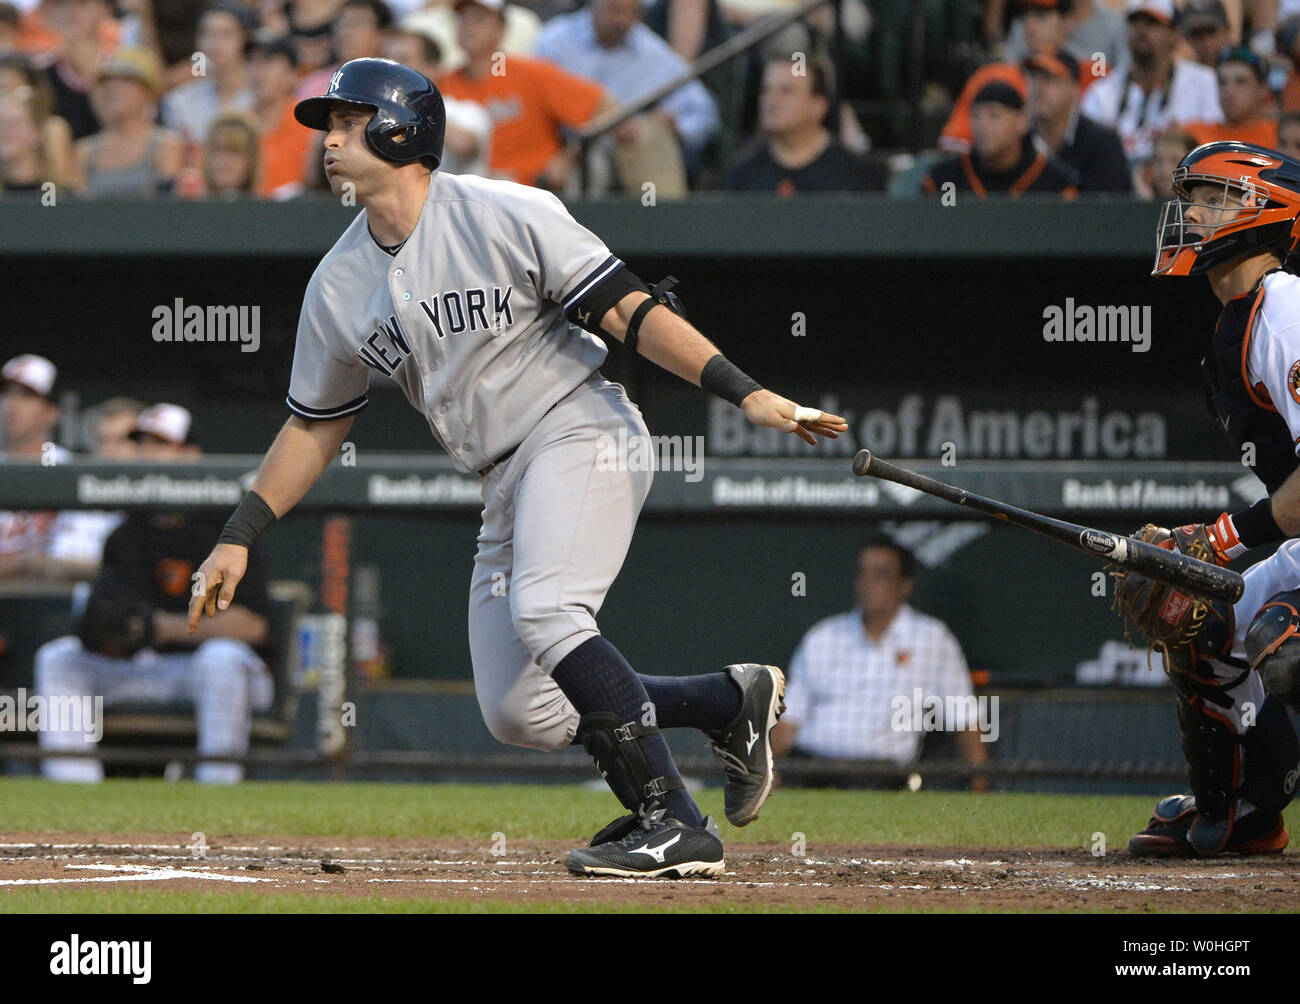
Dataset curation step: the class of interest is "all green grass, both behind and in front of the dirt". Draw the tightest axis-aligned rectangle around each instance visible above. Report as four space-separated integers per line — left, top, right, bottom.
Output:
0 778 1300 913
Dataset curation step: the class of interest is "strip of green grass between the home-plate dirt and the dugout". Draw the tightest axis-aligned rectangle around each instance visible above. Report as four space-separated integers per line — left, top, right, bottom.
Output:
0 778 1242 848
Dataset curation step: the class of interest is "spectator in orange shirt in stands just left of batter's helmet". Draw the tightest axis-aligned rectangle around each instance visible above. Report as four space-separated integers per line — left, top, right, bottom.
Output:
248 39 315 199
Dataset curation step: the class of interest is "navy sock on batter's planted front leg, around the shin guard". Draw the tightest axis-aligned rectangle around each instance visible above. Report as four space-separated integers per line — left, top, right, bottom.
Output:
551 635 707 826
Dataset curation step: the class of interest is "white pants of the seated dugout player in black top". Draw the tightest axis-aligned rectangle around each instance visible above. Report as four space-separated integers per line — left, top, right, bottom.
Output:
35 636 273 784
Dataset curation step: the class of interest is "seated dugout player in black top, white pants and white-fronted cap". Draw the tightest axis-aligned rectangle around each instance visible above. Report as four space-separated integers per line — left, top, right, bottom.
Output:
35 404 272 783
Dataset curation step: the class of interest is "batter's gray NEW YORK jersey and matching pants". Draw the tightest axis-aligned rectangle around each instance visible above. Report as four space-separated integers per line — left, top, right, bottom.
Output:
289 173 653 749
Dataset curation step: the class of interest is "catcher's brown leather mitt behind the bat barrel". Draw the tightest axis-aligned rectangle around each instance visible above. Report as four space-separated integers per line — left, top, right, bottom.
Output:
1108 523 1214 666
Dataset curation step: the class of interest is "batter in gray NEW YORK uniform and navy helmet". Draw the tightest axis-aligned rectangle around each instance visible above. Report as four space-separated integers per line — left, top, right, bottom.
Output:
190 59 848 877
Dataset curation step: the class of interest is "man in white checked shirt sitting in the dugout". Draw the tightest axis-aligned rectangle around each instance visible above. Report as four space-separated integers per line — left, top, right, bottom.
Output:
772 536 988 791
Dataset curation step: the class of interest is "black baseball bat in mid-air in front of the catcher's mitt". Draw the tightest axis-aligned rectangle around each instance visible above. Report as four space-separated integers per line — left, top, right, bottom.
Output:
853 450 1245 603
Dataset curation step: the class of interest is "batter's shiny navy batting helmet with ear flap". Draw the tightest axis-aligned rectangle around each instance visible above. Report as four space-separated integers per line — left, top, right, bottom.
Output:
294 59 447 168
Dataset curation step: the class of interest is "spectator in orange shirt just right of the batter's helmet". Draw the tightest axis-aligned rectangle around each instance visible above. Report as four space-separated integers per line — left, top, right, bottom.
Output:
438 0 614 191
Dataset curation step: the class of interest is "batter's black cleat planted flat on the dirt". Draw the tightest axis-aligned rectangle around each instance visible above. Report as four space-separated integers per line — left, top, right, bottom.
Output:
564 809 723 878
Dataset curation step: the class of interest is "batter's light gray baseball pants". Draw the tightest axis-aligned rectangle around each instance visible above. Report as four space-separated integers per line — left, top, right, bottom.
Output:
469 375 654 750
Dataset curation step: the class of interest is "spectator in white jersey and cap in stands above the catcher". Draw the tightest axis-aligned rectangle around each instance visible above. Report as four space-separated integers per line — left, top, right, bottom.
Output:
1080 0 1223 168
